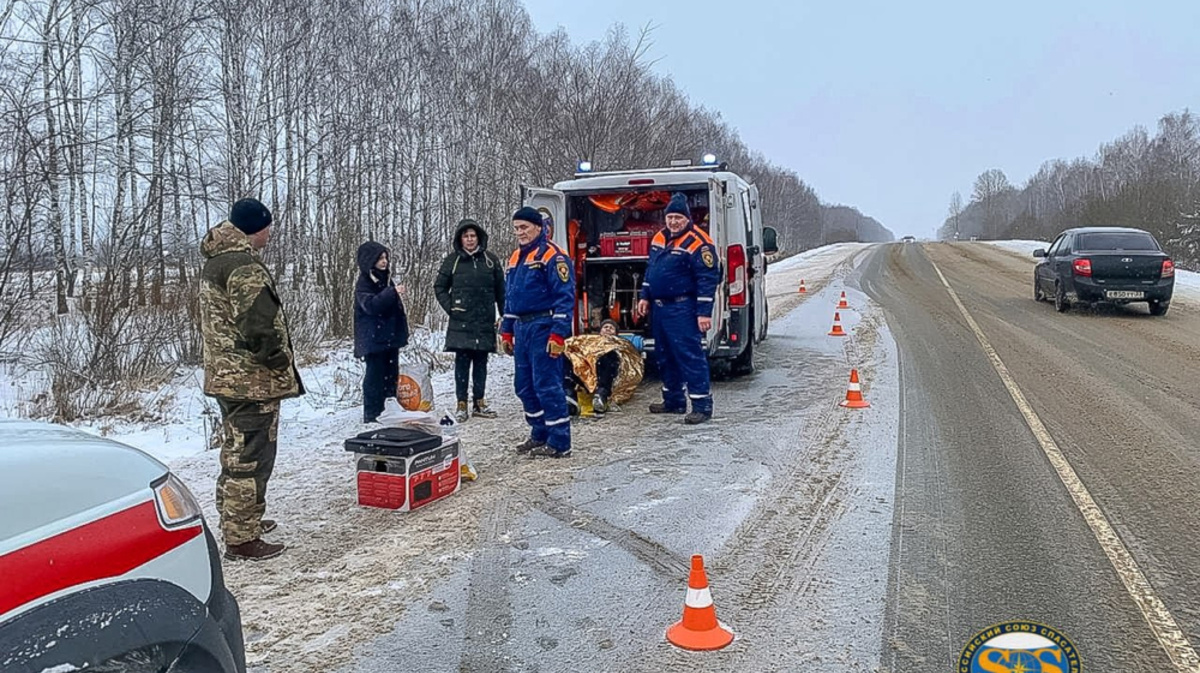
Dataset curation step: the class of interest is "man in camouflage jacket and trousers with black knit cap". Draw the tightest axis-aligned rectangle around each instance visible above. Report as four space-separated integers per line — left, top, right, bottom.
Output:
200 199 304 560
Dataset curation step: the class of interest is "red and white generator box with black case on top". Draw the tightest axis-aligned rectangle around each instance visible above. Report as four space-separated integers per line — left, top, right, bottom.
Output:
344 427 462 512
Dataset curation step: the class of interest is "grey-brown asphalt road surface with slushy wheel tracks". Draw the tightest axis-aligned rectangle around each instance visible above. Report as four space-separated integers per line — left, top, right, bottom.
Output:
862 244 1200 672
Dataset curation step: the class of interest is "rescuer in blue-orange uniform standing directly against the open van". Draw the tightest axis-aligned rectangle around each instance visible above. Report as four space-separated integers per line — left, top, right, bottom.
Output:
637 192 721 425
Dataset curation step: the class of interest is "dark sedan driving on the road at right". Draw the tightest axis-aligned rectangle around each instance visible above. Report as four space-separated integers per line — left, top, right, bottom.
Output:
1033 227 1175 316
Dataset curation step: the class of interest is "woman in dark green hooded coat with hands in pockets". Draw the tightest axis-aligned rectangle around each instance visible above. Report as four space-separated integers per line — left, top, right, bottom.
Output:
433 220 504 422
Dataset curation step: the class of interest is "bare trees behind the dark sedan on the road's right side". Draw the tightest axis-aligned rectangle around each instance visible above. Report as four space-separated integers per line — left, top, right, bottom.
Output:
938 109 1200 269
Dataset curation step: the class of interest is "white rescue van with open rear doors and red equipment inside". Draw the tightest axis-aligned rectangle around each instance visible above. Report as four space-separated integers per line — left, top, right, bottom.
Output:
522 155 778 374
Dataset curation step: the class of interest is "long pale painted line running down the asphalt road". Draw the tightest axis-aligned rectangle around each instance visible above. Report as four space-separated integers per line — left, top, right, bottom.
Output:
929 259 1200 673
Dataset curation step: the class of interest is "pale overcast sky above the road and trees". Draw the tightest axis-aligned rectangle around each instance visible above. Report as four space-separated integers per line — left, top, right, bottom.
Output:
526 0 1200 236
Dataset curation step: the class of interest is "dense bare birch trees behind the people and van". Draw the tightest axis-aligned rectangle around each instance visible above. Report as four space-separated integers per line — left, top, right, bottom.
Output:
0 0 883 417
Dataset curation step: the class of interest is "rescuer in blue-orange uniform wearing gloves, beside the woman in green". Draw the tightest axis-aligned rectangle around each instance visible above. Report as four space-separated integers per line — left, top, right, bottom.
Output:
500 206 575 458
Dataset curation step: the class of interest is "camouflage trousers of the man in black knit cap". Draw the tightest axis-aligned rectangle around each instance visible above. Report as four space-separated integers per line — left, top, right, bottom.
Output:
217 398 280 545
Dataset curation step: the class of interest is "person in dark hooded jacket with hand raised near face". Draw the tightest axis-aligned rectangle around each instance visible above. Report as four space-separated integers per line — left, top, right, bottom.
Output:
354 241 408 423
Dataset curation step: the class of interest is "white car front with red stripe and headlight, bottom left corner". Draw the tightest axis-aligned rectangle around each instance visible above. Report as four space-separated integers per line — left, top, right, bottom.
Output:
0 420 246 673
